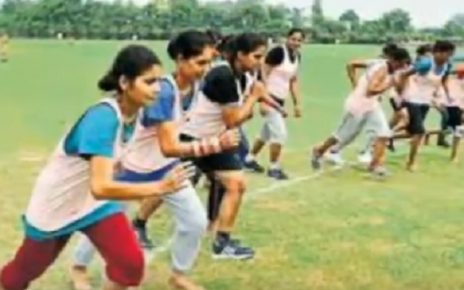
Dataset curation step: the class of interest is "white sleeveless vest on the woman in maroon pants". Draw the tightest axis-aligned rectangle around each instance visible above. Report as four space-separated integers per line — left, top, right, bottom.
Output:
26 98 130 232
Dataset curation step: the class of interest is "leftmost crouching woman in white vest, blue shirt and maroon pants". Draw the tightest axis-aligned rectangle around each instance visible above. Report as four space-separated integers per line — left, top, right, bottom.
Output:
0 45 191 290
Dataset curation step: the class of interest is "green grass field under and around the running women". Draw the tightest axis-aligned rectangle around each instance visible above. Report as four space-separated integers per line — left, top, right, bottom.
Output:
0 40 464 290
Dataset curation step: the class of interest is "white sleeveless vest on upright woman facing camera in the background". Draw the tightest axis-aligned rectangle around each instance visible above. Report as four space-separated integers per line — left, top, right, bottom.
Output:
266 45 299 100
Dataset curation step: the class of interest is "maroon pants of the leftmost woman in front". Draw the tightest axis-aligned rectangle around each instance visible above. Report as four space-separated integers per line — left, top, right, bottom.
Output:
0 213 144 290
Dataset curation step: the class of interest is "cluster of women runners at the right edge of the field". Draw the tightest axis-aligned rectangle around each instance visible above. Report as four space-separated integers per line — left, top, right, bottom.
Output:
311 40 464 174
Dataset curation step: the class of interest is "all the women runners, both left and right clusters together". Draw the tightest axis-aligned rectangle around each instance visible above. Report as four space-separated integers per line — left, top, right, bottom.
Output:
0 29 464 290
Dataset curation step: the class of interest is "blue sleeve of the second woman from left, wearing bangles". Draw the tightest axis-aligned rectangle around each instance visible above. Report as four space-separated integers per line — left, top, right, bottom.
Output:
142 81 175 127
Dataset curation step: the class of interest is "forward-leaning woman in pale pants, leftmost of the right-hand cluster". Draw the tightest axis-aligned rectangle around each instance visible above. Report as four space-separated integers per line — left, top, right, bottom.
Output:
311 48 409 177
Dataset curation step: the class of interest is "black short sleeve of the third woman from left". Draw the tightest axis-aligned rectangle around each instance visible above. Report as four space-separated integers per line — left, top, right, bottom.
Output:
202 65 247 105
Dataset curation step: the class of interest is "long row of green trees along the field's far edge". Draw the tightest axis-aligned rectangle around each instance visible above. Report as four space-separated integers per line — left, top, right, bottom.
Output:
0 0 464 43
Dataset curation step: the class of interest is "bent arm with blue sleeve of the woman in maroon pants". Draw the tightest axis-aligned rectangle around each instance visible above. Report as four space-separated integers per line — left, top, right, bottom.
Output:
73 104 192 200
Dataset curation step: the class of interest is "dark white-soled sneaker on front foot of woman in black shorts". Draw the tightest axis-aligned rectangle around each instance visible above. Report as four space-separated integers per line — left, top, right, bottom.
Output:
213 240 255 260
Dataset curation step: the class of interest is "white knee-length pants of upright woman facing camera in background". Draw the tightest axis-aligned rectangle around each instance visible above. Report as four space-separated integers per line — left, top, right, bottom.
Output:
259 108 288 145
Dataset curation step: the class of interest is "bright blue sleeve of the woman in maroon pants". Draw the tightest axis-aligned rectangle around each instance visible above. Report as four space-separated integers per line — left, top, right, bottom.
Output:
64 104 119 158
